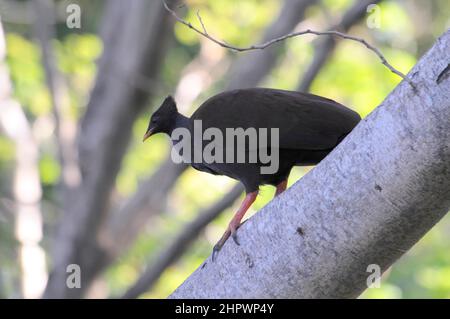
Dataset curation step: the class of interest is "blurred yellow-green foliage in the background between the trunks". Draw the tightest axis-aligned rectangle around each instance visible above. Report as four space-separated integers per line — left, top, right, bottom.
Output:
0 0 450 298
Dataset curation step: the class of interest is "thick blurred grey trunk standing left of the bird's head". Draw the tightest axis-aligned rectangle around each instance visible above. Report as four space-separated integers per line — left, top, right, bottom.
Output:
45 0 175 298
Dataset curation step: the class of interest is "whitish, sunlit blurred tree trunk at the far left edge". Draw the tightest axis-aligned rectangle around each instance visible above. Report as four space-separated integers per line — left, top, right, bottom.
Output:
0 17 47 298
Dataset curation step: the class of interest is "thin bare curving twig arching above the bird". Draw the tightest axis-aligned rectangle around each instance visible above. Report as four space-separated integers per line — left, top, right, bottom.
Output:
163 0 415 88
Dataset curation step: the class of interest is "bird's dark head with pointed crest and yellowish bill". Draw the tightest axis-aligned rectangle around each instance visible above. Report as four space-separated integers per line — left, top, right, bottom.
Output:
143 95 178 141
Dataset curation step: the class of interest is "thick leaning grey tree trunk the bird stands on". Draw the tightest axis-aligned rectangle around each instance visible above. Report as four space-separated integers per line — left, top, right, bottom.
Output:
171 30 450 298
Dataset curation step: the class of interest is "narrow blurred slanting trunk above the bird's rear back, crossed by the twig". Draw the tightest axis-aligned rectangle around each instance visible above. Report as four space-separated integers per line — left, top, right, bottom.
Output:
297 0 381 92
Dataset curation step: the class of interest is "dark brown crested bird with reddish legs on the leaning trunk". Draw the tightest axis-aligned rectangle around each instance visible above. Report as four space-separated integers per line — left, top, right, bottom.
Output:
144 88 361 260
